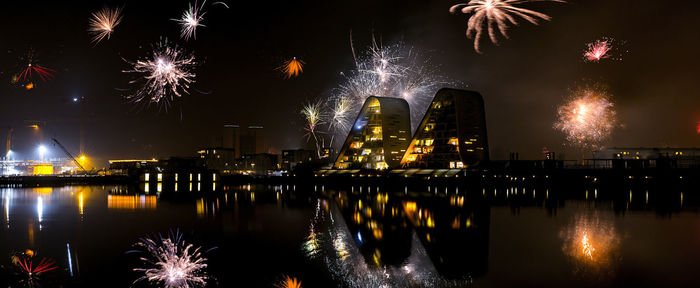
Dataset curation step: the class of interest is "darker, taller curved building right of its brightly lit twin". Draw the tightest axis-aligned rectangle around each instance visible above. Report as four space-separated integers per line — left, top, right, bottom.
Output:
401 88 489 168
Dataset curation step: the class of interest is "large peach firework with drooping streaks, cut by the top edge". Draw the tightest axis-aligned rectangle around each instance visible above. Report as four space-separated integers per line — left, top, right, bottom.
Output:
450 0 566 53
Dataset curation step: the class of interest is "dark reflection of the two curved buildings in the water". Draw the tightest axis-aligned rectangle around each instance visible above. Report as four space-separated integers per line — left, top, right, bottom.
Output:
336 192 490 286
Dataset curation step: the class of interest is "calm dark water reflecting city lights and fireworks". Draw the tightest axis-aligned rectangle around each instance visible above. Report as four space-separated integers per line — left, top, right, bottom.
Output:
0 184 700 287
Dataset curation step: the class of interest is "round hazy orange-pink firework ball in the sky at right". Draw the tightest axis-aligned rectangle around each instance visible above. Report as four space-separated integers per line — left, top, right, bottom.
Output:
554 87 616 148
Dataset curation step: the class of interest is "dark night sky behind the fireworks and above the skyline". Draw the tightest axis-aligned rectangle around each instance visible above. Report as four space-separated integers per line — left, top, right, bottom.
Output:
0 0 700 163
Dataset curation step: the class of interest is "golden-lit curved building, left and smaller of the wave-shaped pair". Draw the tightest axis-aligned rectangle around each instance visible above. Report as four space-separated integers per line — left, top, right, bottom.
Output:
333 96 411 169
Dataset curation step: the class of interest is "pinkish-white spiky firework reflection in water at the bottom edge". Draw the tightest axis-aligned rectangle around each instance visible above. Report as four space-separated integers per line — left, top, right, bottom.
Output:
134 233 208 288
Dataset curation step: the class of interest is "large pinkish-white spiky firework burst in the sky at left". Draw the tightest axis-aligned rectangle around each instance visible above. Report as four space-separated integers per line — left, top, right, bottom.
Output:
122 39 197 106
